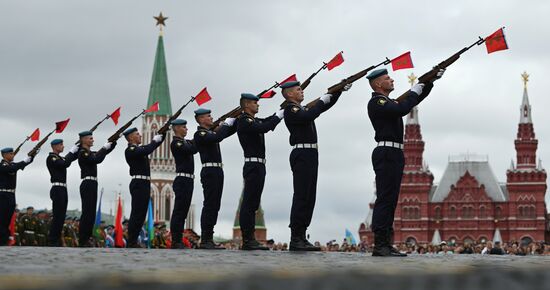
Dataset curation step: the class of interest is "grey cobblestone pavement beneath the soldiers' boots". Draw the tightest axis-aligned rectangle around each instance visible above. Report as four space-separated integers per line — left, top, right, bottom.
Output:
0 247 550 290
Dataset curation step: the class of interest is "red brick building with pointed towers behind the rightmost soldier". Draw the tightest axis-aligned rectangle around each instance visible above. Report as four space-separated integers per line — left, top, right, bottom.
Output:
359 73 549 244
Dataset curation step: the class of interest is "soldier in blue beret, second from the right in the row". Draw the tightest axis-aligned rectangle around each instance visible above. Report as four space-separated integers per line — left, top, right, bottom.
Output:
281 81 351 251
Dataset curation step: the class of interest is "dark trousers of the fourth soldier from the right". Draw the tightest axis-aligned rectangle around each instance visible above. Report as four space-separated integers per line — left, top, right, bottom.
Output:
201 167 224 233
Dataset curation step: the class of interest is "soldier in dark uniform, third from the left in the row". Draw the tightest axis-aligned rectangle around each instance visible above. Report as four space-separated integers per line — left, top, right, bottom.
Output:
78 131 116 247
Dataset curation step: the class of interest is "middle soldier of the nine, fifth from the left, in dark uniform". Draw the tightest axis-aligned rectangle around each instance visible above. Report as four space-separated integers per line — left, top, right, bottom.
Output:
170 119 202 249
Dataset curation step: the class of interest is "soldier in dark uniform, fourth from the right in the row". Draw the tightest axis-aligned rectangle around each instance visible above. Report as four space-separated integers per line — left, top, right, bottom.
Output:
194 108 236 249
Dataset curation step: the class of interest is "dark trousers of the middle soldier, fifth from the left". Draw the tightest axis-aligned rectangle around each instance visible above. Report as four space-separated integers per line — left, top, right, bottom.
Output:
170 176 193 243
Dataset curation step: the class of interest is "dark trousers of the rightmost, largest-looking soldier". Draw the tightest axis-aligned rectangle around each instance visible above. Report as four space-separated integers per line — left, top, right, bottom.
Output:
372 147 405 232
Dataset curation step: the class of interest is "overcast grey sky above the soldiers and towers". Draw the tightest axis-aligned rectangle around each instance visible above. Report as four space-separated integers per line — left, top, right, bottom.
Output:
0 0 550 242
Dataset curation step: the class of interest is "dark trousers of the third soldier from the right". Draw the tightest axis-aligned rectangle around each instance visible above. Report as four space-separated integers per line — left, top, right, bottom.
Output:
239 162 265 232
